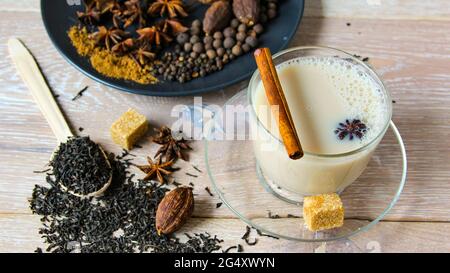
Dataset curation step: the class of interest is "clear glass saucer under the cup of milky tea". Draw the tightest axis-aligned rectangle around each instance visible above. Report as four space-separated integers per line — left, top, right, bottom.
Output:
204 92 407 242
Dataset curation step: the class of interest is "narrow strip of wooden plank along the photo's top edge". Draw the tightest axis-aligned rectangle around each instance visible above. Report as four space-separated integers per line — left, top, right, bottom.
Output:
0 0 450 21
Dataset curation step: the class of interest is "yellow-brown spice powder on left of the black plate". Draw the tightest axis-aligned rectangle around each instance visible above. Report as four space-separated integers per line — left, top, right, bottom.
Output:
68 26 158 84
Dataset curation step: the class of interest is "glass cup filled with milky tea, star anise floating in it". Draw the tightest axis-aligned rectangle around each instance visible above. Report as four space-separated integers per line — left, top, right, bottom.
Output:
248 47 392 203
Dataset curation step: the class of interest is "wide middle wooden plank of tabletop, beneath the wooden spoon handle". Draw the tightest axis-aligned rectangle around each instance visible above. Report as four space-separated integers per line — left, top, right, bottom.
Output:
0 12 450 221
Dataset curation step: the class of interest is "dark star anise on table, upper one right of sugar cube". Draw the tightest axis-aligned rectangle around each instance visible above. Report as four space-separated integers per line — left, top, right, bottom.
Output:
153 126 191 161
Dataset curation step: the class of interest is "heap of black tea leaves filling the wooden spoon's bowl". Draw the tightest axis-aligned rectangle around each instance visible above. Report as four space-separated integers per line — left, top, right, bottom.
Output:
49 137 111 195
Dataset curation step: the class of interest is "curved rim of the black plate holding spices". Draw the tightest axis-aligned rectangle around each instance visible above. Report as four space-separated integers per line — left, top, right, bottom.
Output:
40 0 305 97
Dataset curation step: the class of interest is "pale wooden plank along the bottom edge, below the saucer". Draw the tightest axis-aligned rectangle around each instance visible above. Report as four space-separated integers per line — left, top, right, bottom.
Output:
0 215 450 253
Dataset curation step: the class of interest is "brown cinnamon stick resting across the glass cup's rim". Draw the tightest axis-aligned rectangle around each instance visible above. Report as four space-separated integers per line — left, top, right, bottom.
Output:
254 48 303 159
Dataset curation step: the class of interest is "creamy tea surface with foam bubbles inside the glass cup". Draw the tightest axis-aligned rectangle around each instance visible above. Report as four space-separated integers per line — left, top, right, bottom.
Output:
254 57 388 154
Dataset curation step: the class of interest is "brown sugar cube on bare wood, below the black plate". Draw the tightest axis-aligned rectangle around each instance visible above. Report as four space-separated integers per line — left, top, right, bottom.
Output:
110 109 148 150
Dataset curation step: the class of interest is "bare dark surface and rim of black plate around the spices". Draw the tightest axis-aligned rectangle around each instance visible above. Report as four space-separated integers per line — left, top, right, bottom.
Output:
41 0 304 96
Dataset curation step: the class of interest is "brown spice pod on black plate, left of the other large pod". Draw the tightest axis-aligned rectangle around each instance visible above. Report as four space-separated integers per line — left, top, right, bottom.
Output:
203 1 232 34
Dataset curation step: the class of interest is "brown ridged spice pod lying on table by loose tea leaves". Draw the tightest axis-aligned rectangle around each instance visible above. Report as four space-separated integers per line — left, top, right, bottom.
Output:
156 187 194 234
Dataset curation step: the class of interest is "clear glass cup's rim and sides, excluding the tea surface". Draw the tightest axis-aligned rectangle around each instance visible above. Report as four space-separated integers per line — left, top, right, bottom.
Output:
247 47 392 203
